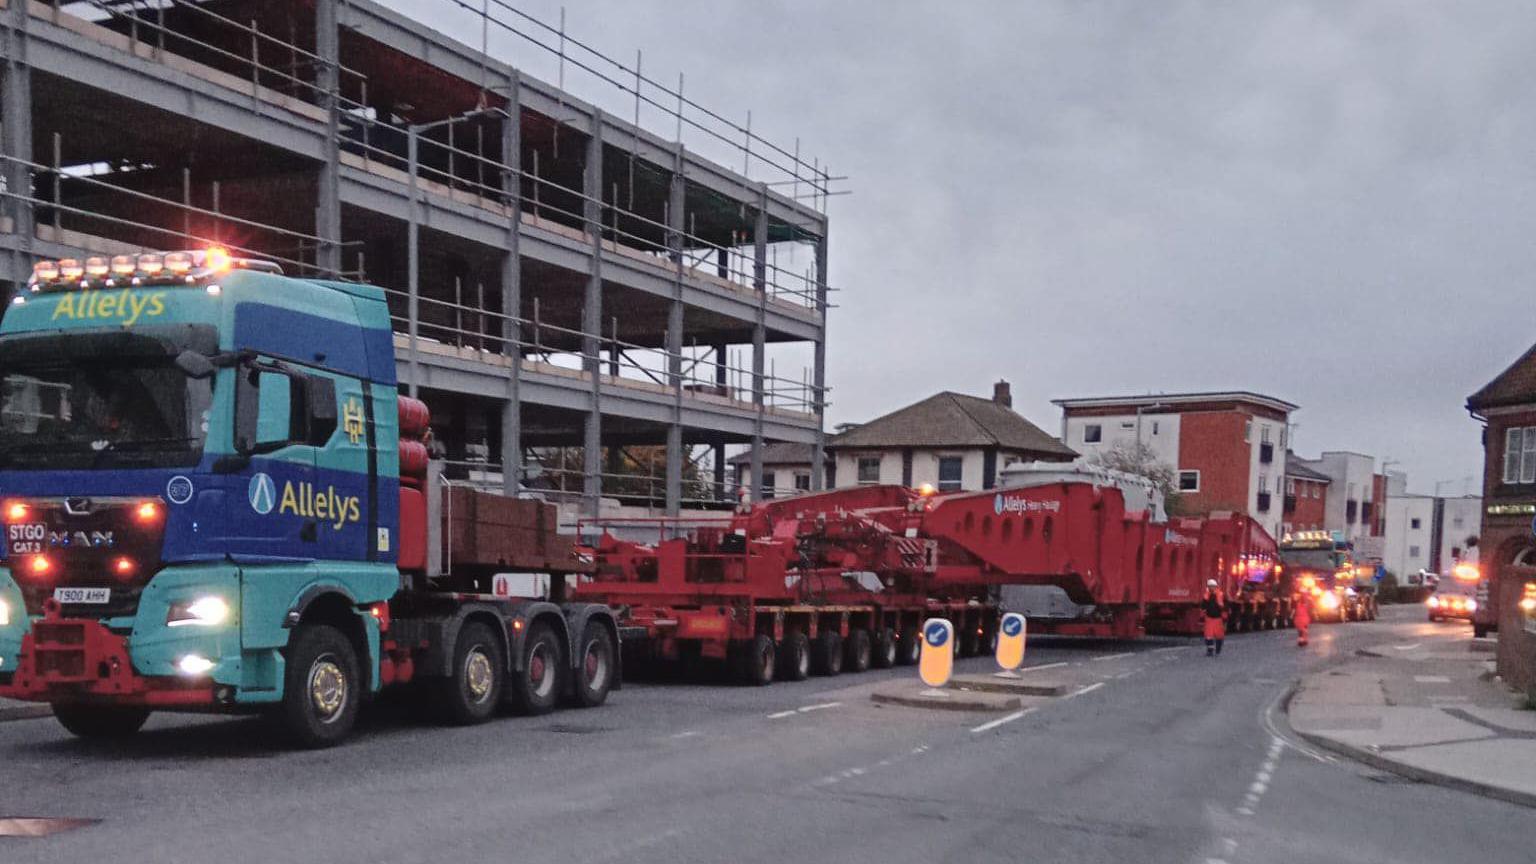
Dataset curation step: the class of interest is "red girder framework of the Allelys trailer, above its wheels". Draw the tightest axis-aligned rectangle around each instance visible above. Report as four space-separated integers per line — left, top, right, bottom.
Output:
578 483 1276 638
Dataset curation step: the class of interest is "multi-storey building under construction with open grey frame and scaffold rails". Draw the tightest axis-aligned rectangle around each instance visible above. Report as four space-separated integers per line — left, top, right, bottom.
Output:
0 0 833 512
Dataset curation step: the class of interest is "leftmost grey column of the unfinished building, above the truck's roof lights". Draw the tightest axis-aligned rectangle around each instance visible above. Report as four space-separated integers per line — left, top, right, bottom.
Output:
0 3 35 295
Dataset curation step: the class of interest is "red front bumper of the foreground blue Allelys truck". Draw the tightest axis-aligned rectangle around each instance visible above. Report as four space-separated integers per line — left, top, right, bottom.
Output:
0 601 219 709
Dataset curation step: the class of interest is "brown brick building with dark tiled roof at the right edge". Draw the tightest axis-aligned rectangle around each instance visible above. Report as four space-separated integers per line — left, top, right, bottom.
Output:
1467 347 1536 693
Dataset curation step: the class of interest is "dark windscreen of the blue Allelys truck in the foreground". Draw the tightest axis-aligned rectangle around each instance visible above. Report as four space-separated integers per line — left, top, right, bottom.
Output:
0 352 214 470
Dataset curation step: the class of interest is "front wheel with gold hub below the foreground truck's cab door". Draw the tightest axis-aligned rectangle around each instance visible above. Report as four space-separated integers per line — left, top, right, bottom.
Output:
281 624 362 749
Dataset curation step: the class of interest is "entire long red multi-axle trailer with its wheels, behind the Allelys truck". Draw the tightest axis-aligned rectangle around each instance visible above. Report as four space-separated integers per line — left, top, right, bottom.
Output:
576 481 1279 684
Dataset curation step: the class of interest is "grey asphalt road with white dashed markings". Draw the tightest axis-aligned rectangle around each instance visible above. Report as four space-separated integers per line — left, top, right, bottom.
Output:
0 609 1536 864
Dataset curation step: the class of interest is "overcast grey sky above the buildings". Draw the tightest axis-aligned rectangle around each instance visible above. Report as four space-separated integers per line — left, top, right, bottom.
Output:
409 0 1536 492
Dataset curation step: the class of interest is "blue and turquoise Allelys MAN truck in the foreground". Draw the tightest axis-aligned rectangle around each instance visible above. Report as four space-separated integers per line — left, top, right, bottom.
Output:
0 249 621 746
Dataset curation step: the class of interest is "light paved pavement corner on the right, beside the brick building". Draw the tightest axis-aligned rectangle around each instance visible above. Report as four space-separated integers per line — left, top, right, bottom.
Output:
1290 605 1536 807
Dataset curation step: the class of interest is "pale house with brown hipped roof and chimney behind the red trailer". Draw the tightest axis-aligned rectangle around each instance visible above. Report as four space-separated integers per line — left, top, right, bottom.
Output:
826 381 1077 492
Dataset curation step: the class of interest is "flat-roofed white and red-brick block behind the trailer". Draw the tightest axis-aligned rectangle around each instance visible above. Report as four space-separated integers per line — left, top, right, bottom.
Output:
1055 390 1296 538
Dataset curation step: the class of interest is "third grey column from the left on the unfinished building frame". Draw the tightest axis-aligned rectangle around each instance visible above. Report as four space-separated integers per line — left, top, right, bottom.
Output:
501 71 522 495
